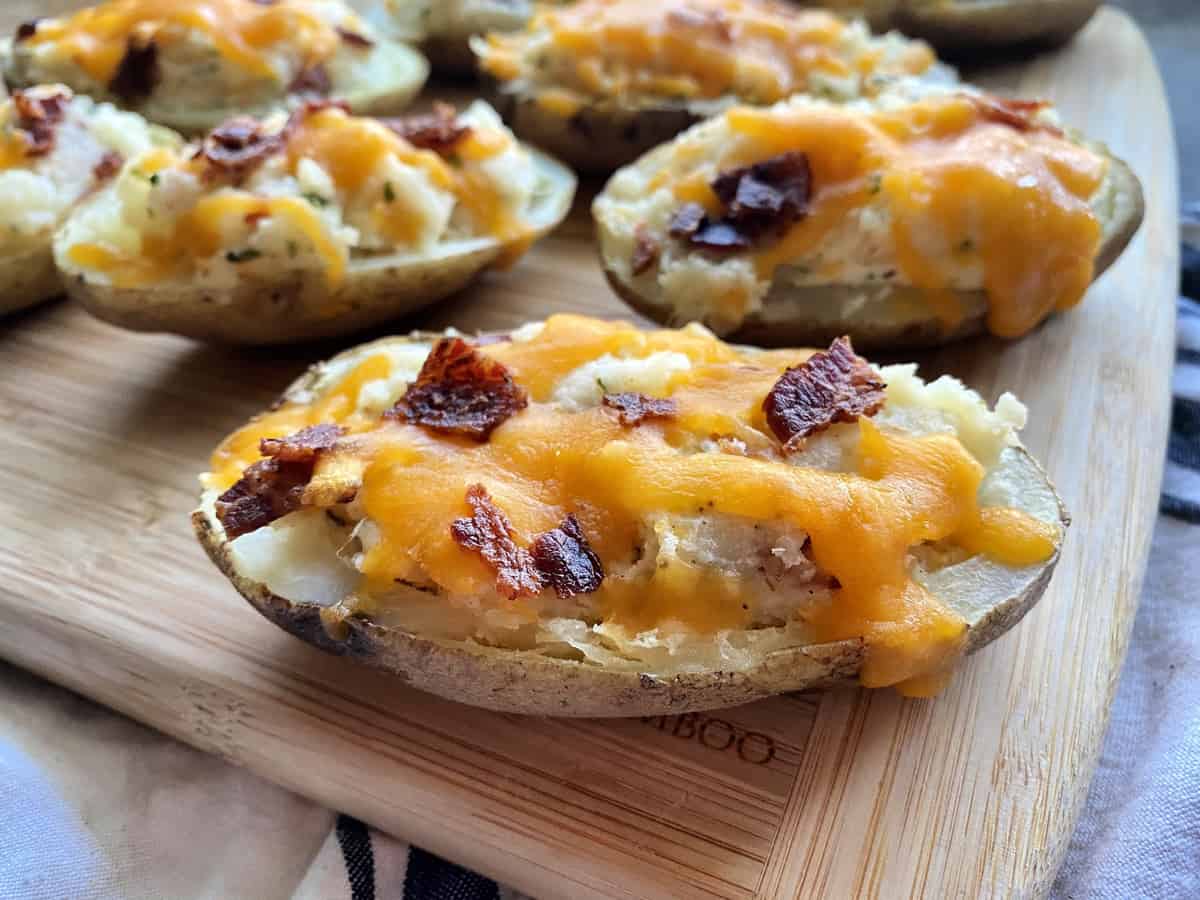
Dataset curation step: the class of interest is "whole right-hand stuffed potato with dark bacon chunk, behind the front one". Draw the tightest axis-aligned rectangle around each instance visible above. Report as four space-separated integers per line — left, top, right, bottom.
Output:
593 88 1142 348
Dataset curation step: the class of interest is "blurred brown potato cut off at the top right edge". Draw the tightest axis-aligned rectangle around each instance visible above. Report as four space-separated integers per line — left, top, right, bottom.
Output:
802 0 1100 54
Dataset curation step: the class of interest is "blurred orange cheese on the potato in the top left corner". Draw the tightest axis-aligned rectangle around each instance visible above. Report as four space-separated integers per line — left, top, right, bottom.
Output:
25 0 340 84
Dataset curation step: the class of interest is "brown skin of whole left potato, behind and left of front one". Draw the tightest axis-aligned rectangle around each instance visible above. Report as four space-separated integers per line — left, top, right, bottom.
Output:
61 155 575 346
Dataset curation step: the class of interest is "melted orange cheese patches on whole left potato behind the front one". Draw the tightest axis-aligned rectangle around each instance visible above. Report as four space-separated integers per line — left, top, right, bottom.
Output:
67 107 533 287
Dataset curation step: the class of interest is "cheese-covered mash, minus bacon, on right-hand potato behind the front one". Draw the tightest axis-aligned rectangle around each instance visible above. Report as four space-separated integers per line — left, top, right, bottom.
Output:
596 92 1109 337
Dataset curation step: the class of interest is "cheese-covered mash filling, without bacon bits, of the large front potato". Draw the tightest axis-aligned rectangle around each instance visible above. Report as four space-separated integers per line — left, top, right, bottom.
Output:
204 316 1060 692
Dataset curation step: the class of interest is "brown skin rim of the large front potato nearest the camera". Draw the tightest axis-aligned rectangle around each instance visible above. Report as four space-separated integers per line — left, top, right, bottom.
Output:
192 334 1069 716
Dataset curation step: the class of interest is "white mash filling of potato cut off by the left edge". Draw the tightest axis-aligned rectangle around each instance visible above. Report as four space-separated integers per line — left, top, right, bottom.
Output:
0 85 169 256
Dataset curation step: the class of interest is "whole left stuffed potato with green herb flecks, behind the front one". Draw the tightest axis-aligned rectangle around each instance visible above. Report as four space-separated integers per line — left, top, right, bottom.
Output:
54 101 575 344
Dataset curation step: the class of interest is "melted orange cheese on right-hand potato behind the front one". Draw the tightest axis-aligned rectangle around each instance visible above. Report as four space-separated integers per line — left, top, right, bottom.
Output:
673 95 1109 337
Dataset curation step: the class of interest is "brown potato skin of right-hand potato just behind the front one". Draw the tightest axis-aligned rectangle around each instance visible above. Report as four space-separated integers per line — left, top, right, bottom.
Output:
596 144 1145 349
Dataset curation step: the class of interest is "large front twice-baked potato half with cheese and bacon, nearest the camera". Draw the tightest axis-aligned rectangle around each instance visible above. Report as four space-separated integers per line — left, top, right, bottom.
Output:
193 316 1067 715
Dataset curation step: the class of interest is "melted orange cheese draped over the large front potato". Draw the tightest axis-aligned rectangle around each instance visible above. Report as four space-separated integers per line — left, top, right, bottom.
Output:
205 316 1057 694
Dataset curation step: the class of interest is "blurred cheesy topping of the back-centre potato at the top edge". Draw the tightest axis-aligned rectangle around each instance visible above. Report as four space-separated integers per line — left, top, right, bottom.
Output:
476 0 936 104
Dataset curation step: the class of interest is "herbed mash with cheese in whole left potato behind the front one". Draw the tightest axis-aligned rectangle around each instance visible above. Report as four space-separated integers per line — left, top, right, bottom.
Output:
65 102 538 288
